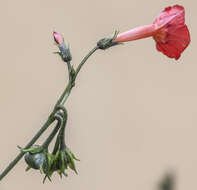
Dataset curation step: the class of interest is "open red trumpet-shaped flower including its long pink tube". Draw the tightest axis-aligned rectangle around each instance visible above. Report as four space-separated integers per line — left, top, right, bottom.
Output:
115 5 190 59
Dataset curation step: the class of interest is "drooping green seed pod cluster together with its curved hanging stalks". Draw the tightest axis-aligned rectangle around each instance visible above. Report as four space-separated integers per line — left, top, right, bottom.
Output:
19 106 79 183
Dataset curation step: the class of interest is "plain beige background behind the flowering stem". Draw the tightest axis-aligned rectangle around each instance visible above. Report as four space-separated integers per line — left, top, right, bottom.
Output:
0 0 197 190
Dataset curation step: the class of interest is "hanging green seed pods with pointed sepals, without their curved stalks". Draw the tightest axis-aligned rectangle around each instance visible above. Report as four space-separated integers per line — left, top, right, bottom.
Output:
21 146 79 183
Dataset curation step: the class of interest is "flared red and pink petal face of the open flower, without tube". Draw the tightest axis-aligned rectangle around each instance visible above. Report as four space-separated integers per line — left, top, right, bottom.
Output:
153 5 190 59
